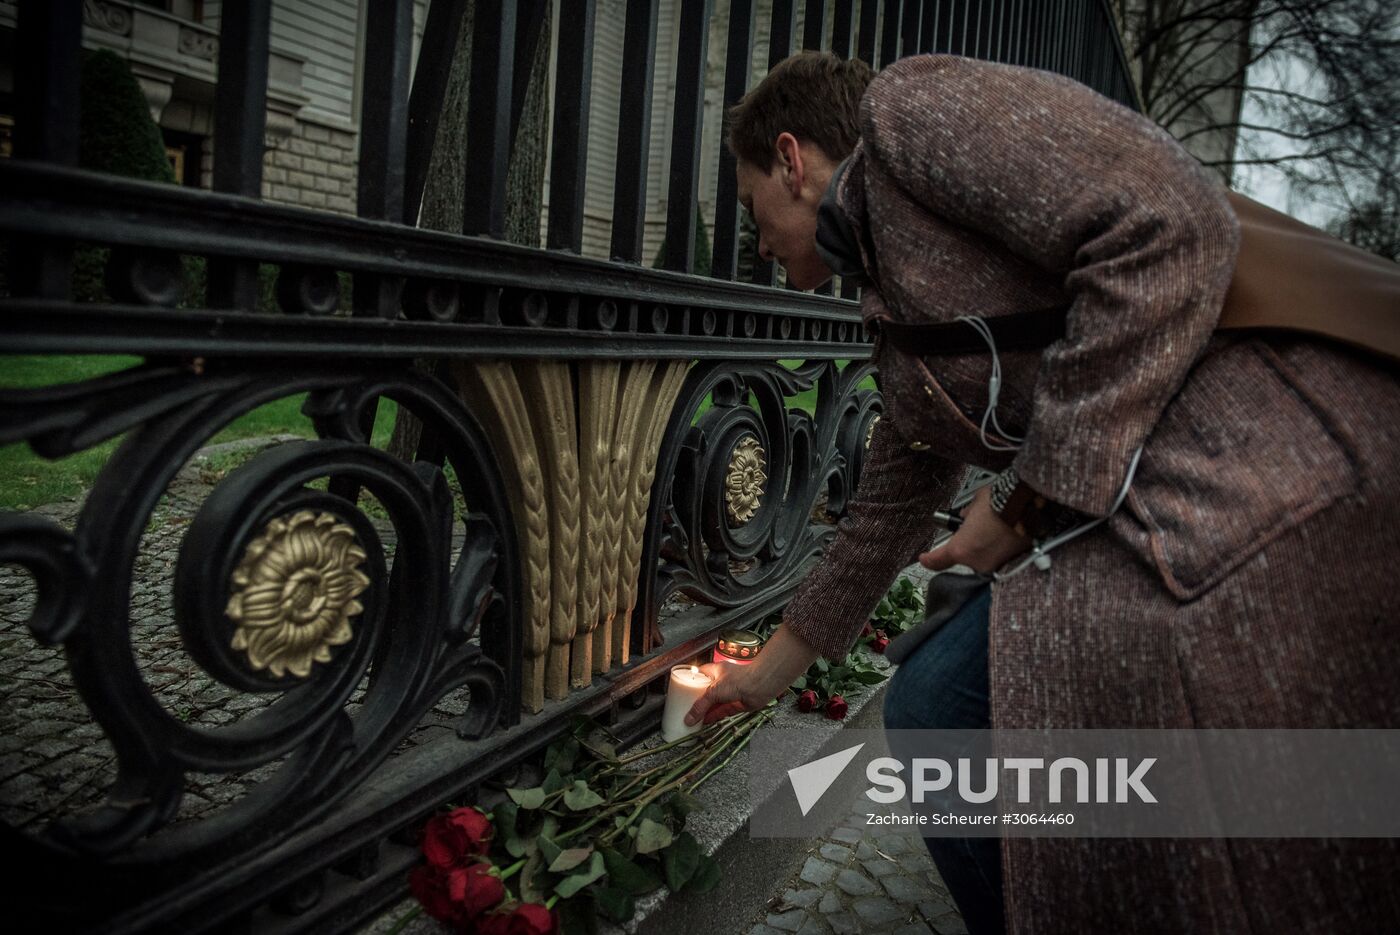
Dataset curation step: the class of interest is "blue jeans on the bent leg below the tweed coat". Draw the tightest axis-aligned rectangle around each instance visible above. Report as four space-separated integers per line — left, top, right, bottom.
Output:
885 585 1007 935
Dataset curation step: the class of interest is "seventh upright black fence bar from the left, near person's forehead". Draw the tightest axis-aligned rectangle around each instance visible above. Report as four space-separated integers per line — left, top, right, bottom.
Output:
665 0 716 273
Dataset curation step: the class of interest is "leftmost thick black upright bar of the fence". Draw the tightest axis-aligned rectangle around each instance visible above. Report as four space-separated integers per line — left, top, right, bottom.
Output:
8 0 83 300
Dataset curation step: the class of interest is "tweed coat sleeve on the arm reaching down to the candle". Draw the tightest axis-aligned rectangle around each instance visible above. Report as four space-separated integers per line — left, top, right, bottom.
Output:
783 419 963 662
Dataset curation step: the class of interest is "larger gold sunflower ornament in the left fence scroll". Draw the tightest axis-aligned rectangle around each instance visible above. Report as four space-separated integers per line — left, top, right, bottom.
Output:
224 509 370 679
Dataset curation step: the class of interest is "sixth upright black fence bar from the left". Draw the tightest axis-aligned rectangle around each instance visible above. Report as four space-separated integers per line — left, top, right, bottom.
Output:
610 0 659 263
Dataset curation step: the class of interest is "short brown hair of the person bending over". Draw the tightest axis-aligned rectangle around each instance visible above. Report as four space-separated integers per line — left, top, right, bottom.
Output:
725 52 875 172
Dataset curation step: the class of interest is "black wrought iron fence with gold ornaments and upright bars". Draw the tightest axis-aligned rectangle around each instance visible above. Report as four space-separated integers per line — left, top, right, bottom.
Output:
0 0 1133 931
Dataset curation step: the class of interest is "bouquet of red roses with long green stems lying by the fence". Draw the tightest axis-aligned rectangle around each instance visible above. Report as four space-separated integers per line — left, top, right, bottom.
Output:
400 705 774 935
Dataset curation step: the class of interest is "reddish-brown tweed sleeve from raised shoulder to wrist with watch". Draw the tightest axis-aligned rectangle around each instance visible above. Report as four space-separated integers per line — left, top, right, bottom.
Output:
861 56 1239 515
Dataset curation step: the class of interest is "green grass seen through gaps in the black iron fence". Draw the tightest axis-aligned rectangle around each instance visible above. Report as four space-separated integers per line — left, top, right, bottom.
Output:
0 356 875 509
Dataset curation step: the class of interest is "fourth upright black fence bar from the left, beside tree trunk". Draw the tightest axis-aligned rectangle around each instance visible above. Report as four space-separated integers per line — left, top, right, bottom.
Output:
462 0 517 238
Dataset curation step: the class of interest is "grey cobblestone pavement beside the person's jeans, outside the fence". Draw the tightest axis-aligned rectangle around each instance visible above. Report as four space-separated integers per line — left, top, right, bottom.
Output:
739 805 967 935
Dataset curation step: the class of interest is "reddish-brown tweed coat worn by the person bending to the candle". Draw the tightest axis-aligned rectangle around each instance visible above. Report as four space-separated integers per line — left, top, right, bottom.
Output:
784 56 1400 932
